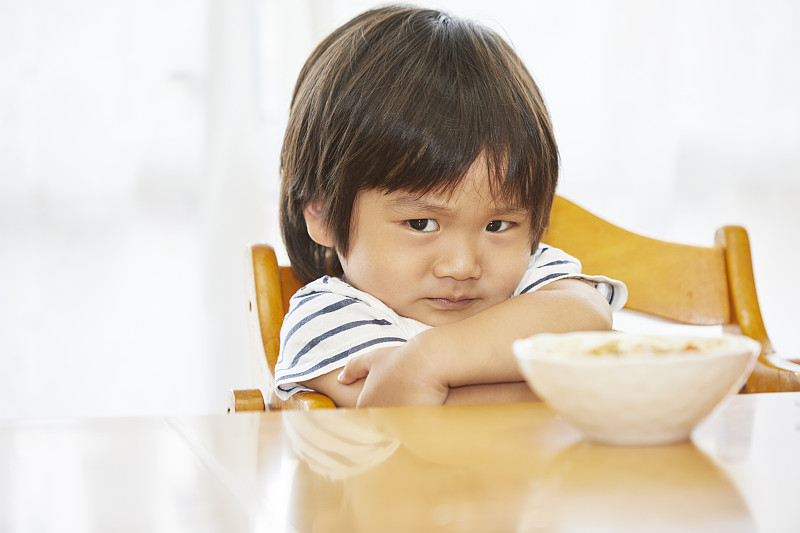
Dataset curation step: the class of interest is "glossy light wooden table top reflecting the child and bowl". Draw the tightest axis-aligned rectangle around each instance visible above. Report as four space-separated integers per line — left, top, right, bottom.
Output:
0 393 800 533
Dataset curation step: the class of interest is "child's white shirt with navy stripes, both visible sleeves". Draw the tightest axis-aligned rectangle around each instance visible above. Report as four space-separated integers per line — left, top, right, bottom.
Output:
275 244 628 399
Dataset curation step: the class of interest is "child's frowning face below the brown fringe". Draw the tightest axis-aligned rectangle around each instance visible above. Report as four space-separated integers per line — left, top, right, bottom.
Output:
340 158 531 326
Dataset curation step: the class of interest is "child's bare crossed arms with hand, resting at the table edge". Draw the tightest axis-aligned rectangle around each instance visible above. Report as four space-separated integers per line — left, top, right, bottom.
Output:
303 279 611 407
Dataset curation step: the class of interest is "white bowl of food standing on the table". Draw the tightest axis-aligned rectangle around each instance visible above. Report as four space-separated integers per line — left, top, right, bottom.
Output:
513 332 761 445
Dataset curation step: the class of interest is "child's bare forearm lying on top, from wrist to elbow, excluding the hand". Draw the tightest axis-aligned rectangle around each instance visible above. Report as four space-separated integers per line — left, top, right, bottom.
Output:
412 280 611 388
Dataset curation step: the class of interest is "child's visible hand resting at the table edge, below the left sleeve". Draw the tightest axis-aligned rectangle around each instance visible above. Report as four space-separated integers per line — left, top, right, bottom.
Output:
339 337 450 407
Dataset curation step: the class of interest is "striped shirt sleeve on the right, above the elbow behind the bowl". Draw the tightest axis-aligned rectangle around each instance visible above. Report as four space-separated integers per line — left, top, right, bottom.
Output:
512 244 628 311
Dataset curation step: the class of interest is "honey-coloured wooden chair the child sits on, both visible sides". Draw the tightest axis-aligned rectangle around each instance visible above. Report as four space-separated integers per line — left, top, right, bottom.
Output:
230 197 800 411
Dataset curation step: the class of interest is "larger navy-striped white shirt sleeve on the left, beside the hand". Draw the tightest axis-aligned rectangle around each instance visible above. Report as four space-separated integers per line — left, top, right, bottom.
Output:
275 277 412 400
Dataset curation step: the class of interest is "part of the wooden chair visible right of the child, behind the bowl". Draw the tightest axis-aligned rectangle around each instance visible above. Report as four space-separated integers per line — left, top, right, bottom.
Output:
542 197 800 392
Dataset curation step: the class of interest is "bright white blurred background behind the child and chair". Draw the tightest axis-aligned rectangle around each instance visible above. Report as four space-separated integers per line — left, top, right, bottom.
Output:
0 0 800 418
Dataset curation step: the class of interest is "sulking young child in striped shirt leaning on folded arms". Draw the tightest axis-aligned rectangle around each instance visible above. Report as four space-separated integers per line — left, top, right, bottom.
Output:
275 6 626 406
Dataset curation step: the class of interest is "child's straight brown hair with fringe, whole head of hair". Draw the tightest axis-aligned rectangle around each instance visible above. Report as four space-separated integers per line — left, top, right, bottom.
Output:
280 6 559 281
